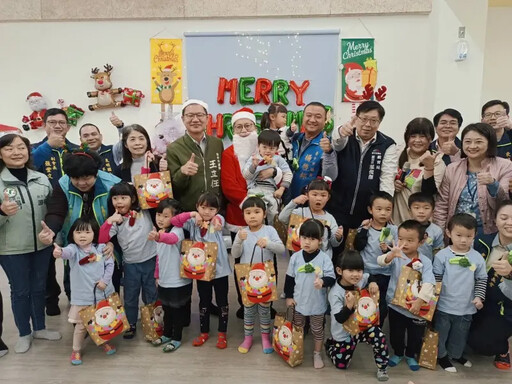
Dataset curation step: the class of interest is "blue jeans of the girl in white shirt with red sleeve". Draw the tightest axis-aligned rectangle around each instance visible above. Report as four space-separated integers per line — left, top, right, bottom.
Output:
123 256 158 325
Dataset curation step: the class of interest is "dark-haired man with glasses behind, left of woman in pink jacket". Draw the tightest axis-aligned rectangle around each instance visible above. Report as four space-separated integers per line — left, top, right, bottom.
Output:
429 108 462 165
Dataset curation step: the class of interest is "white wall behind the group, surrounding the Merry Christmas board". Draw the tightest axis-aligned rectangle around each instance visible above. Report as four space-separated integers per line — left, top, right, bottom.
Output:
0 0 486 148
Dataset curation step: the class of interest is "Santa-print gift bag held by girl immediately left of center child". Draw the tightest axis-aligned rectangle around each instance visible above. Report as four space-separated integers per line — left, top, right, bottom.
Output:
180 240 219 281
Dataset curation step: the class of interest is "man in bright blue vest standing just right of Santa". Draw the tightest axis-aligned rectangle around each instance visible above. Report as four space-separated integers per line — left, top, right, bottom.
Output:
290 101 336 199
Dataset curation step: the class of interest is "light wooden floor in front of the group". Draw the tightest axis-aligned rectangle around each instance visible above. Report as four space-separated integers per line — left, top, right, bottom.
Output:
0 260 512 384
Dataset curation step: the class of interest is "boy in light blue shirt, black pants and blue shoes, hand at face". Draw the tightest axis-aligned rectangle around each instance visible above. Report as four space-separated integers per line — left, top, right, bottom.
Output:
377 220 436 371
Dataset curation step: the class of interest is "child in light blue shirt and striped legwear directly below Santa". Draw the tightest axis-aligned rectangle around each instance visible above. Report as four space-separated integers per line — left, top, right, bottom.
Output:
231 196 284 353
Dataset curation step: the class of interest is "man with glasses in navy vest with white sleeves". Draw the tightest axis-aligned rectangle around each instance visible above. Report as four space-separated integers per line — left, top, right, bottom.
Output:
328 101 398 250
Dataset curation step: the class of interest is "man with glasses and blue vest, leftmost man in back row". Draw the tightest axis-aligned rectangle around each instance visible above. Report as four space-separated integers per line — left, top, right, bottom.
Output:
32 108 78 316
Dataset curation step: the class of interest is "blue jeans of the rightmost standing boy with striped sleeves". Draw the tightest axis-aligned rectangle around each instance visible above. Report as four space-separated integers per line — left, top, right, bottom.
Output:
434 311 473 359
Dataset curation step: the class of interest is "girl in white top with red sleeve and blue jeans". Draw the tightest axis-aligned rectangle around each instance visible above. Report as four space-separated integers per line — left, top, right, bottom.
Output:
100 182 157 339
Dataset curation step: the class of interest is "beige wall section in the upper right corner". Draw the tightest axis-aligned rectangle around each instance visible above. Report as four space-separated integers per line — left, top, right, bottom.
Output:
481 7 512 104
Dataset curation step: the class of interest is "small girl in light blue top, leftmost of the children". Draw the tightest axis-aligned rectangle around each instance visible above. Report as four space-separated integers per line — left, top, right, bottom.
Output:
53 218 116 365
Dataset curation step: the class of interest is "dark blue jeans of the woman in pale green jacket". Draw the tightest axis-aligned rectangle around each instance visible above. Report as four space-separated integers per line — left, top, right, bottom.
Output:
0 247 53 336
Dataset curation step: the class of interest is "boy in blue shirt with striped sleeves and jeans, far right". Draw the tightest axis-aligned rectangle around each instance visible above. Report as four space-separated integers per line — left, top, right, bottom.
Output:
433 213 487 372
